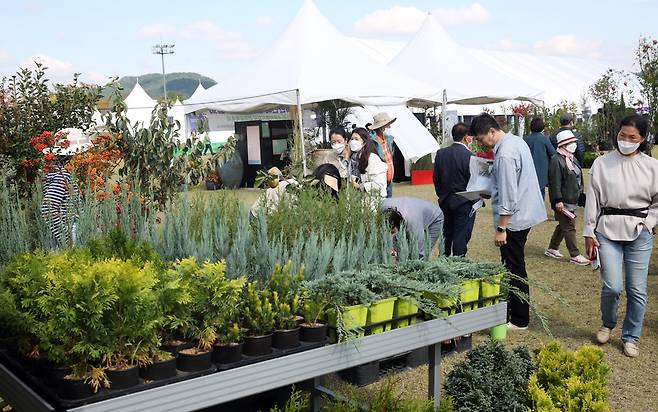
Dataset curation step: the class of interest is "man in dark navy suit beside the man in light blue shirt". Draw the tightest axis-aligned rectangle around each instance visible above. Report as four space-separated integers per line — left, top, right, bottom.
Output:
433 123 475 256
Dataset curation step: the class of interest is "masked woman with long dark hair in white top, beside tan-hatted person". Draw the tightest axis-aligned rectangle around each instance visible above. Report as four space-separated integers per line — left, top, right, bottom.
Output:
350 127 388 198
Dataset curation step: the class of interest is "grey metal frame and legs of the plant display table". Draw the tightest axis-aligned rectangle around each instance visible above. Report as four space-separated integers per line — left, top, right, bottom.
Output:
0 302 507 412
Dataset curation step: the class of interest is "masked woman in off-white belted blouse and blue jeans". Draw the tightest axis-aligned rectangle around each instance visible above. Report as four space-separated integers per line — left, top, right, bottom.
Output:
583 115 658 358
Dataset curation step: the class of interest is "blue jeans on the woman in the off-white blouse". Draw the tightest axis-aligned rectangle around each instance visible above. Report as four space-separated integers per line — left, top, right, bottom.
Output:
596 228 653 342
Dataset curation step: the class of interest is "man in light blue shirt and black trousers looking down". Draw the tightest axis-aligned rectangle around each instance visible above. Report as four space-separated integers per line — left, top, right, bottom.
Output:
470 113 547 330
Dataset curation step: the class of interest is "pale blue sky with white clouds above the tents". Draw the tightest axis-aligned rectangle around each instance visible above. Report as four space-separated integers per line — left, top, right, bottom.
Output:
0 0 658 84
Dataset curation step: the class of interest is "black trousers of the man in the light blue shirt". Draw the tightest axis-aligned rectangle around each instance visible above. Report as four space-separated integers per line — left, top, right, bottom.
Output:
500 229 530 327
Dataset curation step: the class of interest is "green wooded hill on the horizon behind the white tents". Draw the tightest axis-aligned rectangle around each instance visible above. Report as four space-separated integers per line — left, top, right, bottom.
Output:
114 73 217 100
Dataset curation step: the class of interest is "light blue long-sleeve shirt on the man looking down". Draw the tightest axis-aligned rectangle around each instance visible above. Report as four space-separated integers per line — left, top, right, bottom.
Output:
491 133 547 231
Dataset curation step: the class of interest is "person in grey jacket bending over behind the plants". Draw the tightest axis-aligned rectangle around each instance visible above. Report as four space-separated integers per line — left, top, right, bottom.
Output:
382 197 443 258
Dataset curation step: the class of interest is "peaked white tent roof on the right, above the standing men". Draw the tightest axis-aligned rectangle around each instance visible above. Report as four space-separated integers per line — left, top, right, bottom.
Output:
389 14 543 104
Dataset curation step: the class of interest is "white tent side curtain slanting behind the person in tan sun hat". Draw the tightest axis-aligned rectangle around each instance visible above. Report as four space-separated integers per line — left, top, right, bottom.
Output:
346 106 439 163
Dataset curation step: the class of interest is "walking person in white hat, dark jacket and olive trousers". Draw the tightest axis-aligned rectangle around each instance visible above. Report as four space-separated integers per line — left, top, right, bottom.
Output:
544 130 589 266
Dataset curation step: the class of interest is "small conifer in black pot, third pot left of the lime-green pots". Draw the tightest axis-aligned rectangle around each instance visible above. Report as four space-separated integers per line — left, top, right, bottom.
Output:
242 282 274 356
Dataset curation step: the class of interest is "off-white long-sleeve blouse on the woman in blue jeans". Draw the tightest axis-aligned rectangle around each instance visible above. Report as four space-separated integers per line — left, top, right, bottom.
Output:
583 150 658 241
